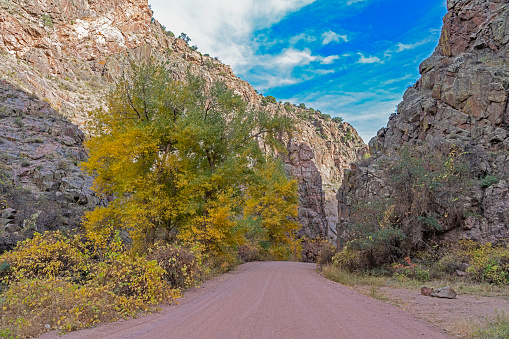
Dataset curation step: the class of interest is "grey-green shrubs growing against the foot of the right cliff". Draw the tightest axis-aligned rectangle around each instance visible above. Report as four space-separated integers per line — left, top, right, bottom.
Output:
337 147 472 269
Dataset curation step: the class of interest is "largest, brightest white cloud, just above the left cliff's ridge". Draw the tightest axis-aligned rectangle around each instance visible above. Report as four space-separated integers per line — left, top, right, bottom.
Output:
149 0 316 72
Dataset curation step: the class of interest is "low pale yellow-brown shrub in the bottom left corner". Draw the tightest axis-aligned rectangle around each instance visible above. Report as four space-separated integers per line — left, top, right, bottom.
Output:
0 278 118 337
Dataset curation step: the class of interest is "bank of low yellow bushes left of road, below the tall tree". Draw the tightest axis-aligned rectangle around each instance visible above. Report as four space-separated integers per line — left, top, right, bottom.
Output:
0 231 183 337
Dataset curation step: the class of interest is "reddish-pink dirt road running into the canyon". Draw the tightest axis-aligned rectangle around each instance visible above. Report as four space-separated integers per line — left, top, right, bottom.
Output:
42 262 451 339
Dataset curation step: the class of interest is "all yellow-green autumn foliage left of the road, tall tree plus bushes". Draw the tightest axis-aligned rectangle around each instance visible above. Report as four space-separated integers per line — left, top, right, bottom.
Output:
0 60 299 337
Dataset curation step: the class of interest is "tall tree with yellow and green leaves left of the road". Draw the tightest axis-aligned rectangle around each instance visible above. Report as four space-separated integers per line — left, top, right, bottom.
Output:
82 60 298 253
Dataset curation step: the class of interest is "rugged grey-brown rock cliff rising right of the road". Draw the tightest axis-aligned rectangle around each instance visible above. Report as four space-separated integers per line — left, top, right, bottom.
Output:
338 0 509 246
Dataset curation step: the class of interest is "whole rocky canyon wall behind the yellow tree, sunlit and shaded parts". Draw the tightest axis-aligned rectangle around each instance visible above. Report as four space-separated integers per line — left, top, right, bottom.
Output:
0 0 367 250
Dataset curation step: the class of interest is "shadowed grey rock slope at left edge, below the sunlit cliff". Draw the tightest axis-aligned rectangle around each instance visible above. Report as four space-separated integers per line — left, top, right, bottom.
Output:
0 80 101 252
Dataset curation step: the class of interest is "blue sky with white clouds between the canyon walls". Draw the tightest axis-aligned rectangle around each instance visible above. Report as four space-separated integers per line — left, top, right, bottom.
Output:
149 0 446 142
